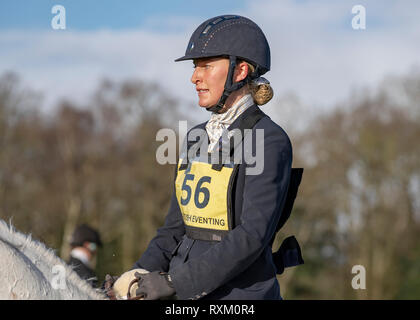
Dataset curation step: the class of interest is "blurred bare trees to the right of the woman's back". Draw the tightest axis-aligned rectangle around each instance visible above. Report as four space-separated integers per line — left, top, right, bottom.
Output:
279 69 420 299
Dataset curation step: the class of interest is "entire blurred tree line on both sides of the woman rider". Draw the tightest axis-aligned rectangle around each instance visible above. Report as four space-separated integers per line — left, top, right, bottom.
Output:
0 71 420 299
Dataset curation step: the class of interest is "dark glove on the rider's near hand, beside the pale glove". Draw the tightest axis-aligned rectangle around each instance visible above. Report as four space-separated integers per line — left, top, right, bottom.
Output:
136 271 175 300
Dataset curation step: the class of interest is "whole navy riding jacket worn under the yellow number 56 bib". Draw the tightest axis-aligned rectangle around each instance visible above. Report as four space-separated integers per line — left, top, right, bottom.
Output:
133 105 292 300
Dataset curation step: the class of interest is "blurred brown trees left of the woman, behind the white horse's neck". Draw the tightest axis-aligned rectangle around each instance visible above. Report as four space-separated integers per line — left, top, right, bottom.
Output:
0 73 187 280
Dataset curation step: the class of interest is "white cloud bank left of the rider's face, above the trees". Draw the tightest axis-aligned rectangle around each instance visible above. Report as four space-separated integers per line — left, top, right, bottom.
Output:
0 30 192 112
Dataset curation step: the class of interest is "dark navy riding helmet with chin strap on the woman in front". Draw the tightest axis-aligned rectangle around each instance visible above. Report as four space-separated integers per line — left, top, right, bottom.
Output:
175 15 270 112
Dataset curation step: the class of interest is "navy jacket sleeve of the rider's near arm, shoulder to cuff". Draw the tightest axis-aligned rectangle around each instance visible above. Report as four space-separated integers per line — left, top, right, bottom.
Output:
169 124 292 299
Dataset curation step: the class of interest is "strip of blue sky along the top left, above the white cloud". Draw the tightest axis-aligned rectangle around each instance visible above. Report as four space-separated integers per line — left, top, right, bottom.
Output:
0 0 245 32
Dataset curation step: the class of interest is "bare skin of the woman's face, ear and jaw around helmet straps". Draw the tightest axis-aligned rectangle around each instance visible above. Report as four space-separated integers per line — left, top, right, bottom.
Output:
191 58 249 113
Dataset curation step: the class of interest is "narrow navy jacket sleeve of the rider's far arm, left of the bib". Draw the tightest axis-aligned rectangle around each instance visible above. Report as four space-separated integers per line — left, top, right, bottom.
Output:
132 191 185 272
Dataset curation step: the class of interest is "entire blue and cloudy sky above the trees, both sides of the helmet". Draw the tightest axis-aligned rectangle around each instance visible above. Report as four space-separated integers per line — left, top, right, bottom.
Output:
0 0 420 129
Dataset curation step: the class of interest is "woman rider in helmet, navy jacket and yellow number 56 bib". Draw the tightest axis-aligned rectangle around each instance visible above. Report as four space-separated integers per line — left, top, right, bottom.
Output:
111 15 303 299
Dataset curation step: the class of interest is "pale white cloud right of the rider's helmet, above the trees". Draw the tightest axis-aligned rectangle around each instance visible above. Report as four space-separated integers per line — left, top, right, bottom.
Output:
241 1 420 105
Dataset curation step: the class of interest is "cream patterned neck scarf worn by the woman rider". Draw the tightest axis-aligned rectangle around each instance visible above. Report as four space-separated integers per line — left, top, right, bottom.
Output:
206 94 254 152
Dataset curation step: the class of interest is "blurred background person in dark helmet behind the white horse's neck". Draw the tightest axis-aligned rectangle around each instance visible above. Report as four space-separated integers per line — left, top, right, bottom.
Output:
68 224 102 287
